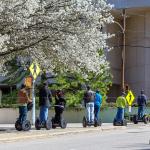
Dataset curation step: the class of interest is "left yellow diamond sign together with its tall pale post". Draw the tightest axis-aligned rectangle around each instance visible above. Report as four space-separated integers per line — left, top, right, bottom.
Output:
29 62 41 125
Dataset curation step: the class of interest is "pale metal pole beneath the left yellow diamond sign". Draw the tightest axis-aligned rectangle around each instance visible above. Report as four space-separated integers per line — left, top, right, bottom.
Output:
32 80 35 125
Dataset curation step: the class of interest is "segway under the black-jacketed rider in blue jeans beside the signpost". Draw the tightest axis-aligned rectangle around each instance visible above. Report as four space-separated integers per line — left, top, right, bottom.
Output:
35 118 52 130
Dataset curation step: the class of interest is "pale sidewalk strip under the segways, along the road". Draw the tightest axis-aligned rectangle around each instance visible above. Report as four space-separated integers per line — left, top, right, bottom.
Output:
0 123 126 142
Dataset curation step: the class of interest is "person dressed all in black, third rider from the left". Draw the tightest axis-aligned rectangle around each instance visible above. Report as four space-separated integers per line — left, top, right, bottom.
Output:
55 90 66 122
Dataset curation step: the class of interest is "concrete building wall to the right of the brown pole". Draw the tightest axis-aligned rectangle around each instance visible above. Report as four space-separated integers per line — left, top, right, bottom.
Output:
125 9 150 97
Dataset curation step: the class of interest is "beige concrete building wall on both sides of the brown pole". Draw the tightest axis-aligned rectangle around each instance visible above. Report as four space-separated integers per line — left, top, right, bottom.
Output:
108 8 150 98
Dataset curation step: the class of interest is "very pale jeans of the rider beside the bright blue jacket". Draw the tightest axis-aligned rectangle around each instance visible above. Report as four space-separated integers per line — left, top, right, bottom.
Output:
86 102 94 122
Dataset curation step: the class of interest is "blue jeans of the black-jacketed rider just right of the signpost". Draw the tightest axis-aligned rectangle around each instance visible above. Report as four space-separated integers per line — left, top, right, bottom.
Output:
39 106 48 123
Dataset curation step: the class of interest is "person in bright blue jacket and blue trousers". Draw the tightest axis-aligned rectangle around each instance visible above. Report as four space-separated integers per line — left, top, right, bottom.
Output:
94 90 102 120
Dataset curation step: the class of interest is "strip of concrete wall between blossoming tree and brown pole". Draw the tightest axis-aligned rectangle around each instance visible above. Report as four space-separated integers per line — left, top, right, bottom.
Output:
107 20 122 97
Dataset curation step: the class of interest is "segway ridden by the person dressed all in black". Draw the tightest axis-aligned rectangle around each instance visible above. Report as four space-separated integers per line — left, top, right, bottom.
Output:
52 105 67 129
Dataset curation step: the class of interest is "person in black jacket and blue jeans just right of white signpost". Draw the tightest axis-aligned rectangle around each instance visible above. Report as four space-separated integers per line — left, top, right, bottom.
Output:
39 83 52 123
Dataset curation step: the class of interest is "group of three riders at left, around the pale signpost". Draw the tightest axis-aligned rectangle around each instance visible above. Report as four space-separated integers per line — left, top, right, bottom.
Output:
18 82 66 124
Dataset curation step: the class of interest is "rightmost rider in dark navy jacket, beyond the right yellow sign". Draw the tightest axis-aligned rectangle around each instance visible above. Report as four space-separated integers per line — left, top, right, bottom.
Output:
137 90 147 119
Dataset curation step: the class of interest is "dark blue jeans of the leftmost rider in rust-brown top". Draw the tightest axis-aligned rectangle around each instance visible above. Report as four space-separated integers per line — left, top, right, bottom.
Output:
19 106 27 124
